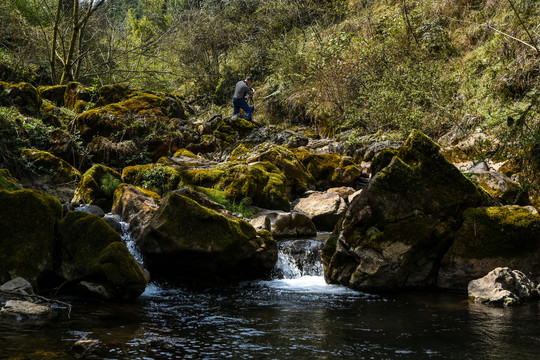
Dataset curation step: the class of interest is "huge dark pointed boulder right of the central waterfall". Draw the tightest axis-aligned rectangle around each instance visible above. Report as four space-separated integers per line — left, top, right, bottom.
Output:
325 131 494 290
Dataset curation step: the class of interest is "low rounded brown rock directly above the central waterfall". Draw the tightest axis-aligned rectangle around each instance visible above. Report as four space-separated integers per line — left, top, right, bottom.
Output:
249 212 317 237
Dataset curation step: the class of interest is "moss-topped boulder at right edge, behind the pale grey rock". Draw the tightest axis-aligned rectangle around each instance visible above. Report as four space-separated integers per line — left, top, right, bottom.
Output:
438 206 540 291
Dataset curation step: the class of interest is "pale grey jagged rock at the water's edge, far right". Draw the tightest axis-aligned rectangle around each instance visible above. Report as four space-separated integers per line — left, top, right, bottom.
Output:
467 267 539 306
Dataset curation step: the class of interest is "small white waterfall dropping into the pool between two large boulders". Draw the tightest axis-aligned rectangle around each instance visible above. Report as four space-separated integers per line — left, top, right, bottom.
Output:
273 240 324 279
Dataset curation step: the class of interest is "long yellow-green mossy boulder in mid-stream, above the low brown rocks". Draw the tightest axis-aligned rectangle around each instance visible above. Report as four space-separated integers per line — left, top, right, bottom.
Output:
179 161 291 211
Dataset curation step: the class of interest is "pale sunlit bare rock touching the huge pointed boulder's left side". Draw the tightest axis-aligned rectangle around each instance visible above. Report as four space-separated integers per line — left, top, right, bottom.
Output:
294 192 347 231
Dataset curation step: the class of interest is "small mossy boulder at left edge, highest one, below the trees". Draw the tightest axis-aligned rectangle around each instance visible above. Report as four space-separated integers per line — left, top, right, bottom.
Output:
0 83 43 116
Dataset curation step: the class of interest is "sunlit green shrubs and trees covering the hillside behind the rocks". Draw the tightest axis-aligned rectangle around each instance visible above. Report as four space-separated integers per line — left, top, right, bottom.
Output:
0 0 540 144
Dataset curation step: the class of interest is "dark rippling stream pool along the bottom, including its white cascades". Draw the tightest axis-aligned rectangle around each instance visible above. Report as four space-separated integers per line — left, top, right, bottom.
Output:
0 227 540 360
